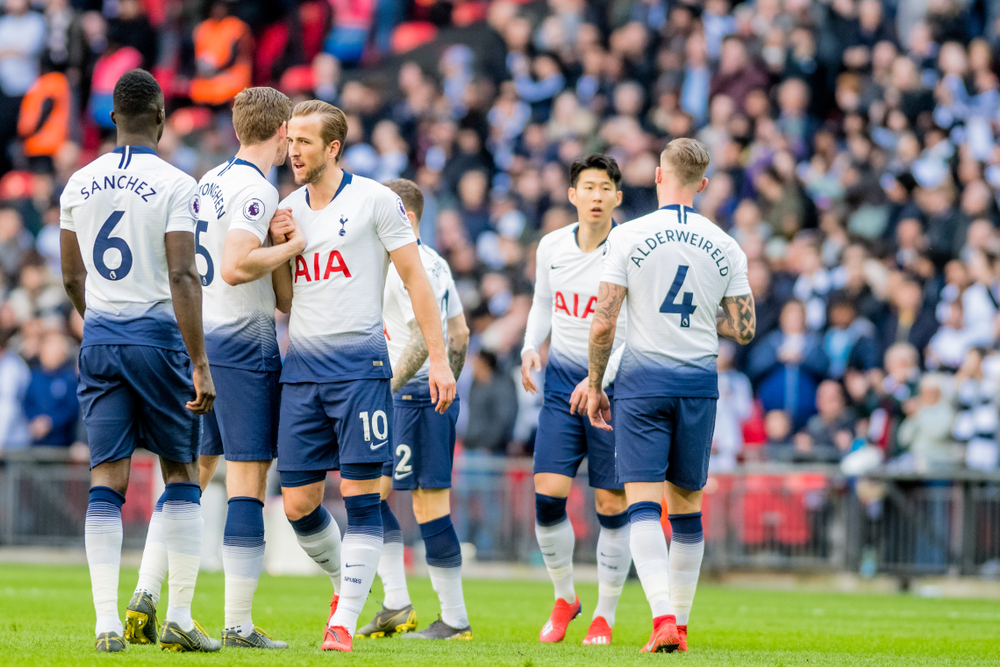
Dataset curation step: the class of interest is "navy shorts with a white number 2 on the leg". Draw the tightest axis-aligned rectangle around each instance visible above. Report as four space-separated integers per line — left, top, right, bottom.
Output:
382 397 459 491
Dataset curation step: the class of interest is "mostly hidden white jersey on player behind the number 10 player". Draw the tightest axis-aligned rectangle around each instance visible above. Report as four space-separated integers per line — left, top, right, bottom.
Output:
382 241 462 401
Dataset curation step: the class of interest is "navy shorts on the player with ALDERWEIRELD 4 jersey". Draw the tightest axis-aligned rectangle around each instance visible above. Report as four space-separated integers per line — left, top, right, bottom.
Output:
612 396 718 491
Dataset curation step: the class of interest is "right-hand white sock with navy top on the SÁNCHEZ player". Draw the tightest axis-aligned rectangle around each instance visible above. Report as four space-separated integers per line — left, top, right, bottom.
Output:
163 482 205 630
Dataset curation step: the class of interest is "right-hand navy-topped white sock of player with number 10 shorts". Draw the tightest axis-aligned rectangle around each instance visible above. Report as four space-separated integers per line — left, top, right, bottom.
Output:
330 493 382 635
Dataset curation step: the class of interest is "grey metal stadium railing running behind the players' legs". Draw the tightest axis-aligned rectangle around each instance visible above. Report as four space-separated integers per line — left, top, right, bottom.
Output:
0 448 1000 579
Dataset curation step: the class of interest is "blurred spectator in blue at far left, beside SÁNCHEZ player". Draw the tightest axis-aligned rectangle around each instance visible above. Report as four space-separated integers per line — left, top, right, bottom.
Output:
24 331 80 447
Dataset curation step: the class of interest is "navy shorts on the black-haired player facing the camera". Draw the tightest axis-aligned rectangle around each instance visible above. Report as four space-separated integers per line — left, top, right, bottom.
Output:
534 393 622 489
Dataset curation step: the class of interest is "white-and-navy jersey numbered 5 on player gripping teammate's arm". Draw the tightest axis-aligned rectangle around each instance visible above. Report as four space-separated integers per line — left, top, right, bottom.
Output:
195 157 281 371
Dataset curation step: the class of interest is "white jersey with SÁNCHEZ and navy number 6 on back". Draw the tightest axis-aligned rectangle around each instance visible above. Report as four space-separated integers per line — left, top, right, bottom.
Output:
59 146 198 351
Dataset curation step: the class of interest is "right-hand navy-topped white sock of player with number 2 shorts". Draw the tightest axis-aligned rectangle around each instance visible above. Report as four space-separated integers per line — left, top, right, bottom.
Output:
420 514 469 628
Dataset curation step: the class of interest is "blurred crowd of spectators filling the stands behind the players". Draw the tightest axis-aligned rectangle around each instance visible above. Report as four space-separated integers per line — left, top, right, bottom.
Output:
0 0 1000 480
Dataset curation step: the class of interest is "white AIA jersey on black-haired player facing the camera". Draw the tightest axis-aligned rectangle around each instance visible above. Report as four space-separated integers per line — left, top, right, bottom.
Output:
521 223 626 396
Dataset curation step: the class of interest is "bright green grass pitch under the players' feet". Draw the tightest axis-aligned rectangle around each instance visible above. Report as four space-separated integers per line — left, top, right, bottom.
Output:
0 565 1000 667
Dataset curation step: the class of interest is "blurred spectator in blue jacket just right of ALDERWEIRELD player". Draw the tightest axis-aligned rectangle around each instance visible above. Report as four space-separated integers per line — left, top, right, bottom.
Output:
747 300 829 431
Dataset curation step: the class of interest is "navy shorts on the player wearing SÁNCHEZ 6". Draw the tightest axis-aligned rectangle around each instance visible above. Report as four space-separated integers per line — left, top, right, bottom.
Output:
77 345 201 468
